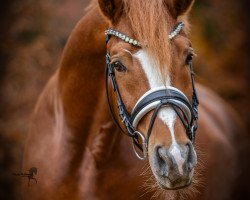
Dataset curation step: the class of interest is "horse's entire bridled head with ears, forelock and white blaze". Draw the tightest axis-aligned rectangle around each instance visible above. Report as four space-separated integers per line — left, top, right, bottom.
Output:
99 0 198 189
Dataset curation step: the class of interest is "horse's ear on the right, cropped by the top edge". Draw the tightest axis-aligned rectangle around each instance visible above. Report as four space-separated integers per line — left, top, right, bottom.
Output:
172 0 194 18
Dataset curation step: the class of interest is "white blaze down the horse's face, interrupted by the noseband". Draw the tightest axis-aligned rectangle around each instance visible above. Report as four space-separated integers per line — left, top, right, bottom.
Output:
134 50 185 174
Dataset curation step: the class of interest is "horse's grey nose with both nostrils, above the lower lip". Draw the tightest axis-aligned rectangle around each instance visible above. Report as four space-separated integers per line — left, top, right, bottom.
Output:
155 142 197 182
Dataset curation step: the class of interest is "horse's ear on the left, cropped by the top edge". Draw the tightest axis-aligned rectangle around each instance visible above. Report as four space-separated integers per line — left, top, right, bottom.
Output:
98 0 122 22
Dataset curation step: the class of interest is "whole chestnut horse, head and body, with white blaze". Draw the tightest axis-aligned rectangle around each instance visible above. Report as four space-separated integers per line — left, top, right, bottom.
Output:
23 0 241 200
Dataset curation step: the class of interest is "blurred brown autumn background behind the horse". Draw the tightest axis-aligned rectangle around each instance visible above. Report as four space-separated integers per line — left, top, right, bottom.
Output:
0 0 250 199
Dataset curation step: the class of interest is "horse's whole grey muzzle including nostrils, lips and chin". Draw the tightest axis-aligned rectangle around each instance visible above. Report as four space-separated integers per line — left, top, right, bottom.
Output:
149 142 197 190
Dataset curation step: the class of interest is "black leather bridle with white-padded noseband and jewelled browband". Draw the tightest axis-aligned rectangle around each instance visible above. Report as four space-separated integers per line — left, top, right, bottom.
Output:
105 22 199 160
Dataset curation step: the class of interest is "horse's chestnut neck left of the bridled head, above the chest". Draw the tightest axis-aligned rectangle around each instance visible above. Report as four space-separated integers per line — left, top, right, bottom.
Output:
58 5 123 167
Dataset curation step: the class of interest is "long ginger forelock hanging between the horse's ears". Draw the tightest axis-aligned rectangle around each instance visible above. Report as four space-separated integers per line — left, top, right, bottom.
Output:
123 0 189 82
